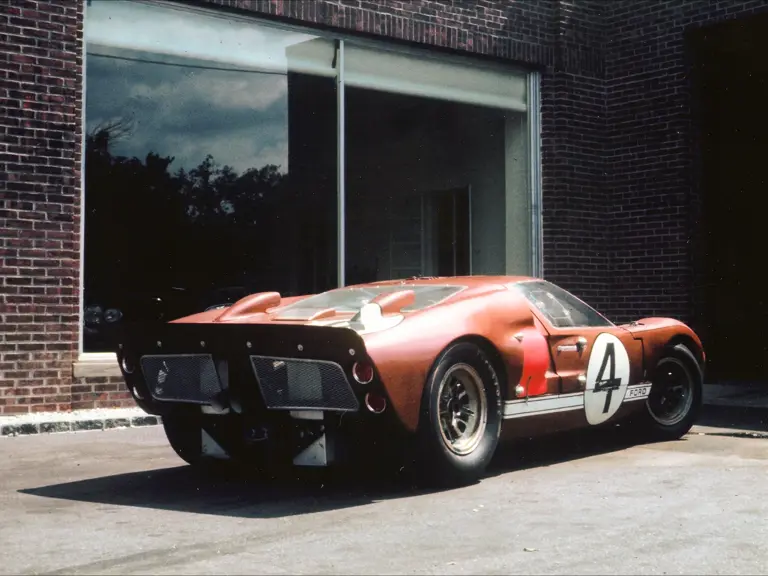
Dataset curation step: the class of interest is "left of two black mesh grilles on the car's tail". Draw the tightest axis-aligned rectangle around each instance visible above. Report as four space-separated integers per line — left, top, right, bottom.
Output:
141 354 222 404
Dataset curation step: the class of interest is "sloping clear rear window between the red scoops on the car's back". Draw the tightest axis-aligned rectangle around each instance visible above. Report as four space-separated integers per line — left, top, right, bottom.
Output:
276 284 464 319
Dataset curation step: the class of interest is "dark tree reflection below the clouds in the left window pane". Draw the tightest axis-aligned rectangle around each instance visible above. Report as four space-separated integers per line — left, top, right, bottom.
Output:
84 118 288 348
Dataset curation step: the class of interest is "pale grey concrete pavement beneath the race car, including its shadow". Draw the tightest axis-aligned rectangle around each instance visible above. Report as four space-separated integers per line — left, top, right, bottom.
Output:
0 415 768 574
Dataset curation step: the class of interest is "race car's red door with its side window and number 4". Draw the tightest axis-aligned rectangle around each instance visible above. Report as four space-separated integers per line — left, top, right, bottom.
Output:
519 281 642 398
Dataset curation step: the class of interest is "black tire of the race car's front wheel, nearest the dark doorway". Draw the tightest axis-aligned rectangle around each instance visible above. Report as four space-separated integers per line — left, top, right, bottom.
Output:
629 344 704 442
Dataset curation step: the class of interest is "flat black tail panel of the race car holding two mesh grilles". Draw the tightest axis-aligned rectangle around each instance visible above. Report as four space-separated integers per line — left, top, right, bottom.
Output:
115 323 385 413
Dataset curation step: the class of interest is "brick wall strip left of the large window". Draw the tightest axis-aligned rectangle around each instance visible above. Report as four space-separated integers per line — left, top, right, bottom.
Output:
0 0 83 413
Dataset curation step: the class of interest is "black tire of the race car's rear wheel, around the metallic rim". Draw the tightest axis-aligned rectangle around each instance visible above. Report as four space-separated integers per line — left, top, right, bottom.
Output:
419 342 503 481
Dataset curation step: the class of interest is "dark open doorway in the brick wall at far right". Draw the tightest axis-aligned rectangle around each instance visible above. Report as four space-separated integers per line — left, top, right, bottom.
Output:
691 16 768 381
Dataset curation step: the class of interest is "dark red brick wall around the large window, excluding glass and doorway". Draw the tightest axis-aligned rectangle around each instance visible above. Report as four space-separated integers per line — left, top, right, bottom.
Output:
0 0 764 412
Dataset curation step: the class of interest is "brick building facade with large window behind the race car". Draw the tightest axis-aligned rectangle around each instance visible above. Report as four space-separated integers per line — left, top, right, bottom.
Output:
0 0 765 413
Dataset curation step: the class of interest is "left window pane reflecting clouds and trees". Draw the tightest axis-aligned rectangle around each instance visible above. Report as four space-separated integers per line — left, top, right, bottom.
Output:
84 0 337 352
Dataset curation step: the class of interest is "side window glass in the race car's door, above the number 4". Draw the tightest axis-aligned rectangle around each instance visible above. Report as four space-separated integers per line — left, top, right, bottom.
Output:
517 282 612 328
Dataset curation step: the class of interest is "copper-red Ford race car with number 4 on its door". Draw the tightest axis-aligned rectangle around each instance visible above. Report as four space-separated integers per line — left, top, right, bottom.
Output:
111 276 705 483
